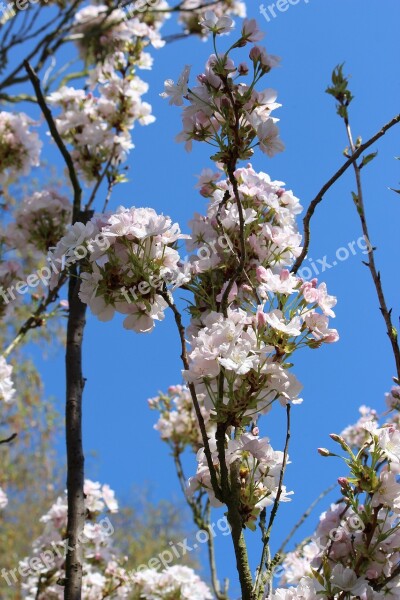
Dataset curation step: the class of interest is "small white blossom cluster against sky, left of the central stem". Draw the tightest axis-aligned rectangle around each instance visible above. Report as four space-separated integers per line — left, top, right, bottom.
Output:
148 385 210 452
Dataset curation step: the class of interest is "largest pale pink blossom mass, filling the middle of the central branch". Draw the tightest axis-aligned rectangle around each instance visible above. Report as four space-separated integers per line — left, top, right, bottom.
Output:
184 165 339 416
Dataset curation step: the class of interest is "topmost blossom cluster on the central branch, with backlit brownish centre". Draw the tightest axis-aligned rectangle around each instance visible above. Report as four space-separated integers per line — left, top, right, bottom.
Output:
161 18 284 158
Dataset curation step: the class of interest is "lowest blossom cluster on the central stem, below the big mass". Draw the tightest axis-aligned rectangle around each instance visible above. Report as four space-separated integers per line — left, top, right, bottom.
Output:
188 433 293 529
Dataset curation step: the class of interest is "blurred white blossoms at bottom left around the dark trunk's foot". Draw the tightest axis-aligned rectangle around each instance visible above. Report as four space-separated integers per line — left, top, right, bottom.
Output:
21 480 212 600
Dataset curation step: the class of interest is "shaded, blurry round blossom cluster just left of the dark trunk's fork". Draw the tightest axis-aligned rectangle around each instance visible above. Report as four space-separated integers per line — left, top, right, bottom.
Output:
7 189 72 252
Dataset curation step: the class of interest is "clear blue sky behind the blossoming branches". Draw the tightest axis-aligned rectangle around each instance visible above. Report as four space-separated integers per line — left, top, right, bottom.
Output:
9 0 400 597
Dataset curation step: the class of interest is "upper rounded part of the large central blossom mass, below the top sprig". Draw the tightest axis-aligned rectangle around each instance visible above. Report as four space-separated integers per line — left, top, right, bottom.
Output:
188 164 302 272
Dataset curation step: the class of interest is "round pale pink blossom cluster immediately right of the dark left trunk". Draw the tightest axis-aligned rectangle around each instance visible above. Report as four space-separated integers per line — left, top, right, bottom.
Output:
50 207 186 333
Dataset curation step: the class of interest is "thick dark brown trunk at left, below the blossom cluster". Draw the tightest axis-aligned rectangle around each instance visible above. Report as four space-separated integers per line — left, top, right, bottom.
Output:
64 268 86 600
